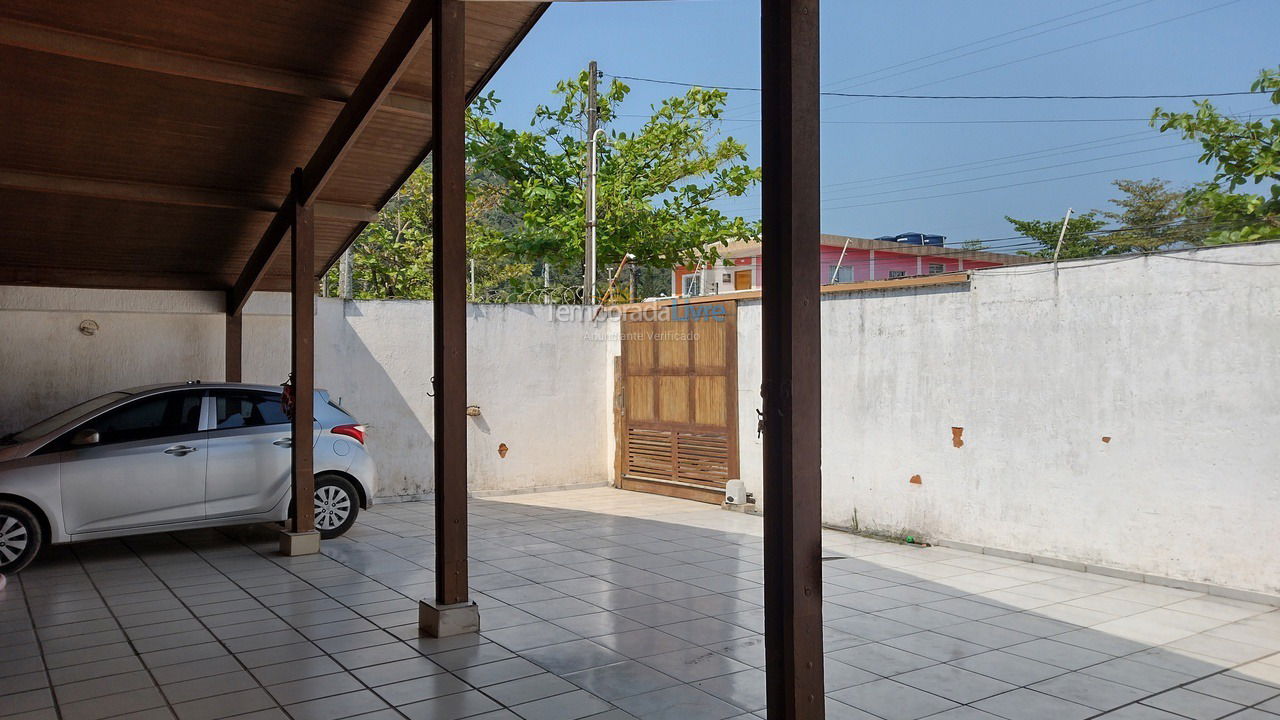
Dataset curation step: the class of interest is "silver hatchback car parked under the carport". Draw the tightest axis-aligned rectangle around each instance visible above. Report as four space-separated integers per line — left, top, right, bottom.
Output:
0 383 374 574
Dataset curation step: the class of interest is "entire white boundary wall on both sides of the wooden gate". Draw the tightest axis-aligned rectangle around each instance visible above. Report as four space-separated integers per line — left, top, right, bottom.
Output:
0 243 1280 594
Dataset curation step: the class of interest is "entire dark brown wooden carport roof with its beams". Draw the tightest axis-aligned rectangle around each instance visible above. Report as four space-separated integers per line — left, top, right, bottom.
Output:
0 0 545 294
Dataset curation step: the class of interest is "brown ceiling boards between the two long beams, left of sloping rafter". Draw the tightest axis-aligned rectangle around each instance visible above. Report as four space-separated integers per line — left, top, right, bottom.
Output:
0 46 340 196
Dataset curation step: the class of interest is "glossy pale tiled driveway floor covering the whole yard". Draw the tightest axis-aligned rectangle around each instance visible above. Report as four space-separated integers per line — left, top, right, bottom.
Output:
0 488 1280 720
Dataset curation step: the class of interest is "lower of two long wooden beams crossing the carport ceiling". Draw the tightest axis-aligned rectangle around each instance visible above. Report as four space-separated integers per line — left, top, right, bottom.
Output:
0 168 378 223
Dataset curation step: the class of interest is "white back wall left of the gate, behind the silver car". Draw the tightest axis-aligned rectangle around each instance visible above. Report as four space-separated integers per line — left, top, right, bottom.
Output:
0 287 612 497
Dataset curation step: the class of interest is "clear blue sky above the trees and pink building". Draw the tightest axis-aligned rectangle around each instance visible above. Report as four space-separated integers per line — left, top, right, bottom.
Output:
489 0 1280 251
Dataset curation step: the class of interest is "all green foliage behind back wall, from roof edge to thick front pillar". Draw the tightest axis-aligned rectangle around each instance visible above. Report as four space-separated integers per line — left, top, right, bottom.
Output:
326 73 760 300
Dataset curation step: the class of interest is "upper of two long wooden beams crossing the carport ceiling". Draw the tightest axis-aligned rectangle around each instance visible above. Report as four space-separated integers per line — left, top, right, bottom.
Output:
0 19 431 117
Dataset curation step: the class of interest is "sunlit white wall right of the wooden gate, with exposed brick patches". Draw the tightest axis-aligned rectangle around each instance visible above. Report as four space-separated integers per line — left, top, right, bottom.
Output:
739 243 1280 594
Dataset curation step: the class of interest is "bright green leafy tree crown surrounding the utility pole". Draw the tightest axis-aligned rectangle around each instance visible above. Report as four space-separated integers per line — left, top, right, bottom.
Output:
467 72 760 275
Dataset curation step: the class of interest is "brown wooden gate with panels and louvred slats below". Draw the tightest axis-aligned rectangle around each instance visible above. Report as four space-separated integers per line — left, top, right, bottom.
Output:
618 300 739 503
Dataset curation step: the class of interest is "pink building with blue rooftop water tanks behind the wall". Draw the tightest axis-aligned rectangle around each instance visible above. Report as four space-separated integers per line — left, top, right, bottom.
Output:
671 234 1037 296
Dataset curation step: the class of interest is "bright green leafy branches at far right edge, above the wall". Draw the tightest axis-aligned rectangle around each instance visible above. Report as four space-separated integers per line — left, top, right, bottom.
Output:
1151 68 1280 245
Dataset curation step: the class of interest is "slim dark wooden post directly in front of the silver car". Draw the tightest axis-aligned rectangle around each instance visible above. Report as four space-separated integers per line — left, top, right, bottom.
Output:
289 168 316 533
